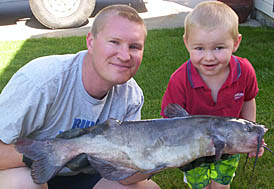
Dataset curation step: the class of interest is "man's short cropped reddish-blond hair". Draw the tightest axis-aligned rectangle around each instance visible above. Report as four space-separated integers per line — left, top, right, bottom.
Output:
91 5 147 37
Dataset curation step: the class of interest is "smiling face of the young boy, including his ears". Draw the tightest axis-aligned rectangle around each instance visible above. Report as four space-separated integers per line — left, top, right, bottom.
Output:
184 27 241 77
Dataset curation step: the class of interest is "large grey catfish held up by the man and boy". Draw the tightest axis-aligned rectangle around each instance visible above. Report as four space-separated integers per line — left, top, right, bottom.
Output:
16 105 267 184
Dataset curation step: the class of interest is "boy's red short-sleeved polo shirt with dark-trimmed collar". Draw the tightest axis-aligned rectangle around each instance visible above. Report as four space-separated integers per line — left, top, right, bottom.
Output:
161 56 259 117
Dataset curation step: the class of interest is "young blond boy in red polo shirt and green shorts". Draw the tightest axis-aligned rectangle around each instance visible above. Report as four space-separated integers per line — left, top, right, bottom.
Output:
161 1 263 188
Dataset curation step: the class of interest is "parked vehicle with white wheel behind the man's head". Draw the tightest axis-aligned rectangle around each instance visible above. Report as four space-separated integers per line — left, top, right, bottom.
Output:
0 0 147 29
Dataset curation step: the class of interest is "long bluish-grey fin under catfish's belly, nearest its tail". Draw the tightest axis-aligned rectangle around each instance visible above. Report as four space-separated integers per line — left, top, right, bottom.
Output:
88 156 137 181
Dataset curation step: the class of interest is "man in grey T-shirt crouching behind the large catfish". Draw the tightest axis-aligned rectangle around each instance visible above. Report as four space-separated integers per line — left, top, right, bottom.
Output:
0 5 159 189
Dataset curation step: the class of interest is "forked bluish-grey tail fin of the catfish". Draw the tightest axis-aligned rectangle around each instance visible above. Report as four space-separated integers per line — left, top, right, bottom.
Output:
15 139 63 184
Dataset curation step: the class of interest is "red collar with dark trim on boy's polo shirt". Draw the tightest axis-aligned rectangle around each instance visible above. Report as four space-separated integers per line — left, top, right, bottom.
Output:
187 56 242 88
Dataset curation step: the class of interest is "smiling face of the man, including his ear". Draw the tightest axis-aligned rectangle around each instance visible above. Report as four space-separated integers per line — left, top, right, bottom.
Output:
87 15 146 85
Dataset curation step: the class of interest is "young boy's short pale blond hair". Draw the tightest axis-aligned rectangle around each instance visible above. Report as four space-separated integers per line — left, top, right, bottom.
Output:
184 1 239 40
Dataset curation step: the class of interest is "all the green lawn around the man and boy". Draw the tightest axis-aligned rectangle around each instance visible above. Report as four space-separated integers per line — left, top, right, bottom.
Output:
0 27 274 189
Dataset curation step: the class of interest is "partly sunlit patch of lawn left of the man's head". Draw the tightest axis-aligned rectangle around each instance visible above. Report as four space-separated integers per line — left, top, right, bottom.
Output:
0 36 86 92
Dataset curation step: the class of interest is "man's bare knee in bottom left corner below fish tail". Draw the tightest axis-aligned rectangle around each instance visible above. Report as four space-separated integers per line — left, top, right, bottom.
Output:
0 167 47 189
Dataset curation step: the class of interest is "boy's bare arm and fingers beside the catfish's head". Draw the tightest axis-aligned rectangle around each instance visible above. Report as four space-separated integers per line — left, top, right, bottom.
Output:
241 98 266 157
